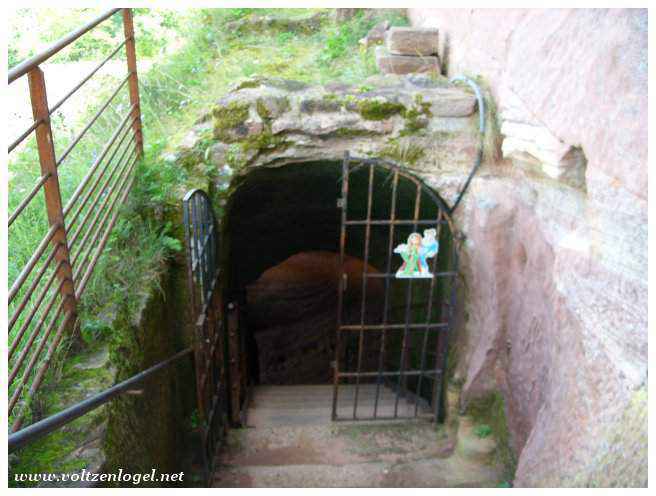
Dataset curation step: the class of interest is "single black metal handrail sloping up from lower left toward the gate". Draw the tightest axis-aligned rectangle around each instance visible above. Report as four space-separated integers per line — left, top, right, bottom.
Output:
9 347 193 453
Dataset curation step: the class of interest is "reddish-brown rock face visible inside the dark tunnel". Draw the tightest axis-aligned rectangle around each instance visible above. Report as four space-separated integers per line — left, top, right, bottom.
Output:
247 252 384 384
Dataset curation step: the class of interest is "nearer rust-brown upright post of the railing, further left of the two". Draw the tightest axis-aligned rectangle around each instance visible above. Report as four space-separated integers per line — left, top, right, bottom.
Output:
27 66 77 330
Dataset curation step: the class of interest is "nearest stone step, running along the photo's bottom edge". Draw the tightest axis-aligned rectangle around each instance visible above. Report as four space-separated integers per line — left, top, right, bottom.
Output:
213 457 499 487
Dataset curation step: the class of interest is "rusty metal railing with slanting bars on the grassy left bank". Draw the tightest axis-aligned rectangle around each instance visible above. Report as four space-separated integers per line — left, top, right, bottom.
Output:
8 9 143 432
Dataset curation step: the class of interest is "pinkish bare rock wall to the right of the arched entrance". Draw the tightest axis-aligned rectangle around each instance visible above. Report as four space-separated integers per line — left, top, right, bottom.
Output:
409 9 647 486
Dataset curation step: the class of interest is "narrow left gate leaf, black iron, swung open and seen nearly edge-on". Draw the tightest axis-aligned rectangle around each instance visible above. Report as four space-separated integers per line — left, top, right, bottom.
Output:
183 189 229 481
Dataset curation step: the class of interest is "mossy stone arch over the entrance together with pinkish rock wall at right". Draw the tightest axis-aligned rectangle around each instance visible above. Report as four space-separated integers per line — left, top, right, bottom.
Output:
168 18 647 480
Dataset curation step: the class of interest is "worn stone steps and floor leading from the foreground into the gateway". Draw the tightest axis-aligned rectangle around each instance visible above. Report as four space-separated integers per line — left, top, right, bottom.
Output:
214 386 500 487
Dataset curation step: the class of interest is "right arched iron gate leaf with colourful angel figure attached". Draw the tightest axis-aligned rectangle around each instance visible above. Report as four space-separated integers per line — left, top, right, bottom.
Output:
332 153 457 420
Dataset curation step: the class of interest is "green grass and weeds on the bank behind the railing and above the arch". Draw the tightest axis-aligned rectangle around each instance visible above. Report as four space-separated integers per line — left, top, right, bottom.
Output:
8 9 416 486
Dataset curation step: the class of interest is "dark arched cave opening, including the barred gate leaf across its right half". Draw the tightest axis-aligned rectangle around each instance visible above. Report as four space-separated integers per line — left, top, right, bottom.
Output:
223 154 456 420
